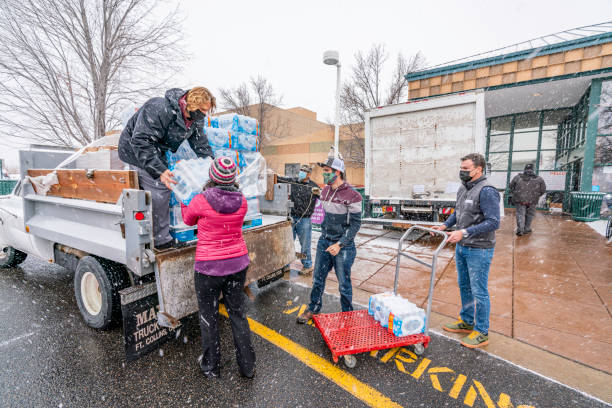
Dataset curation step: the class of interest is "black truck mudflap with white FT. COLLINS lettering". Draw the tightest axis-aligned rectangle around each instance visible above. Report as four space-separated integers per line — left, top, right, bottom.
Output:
119 282 180 362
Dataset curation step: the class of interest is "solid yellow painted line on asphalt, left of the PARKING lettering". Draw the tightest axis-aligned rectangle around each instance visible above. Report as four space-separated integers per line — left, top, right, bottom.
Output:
219 304 401 408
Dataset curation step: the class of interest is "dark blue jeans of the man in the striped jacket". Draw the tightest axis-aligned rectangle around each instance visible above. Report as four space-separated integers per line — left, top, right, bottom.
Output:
308 236 357 313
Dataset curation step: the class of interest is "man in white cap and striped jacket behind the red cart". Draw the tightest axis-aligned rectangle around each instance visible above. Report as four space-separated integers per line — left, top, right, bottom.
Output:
297 157 361 324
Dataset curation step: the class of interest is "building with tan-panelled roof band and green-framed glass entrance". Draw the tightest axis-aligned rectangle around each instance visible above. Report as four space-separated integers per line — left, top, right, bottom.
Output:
406 24 612 208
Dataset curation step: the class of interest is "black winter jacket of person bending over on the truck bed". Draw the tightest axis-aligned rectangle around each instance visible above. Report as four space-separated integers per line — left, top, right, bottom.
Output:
118 88 213 179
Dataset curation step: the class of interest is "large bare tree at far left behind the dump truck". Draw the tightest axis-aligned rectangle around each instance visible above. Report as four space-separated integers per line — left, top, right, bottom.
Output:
0 0 181 146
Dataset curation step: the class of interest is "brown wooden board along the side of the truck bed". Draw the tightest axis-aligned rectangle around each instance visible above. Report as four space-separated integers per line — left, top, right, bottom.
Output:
28 169 138 204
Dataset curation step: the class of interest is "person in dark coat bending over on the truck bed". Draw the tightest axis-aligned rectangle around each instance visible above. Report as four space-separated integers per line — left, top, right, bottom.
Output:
118 87 216 249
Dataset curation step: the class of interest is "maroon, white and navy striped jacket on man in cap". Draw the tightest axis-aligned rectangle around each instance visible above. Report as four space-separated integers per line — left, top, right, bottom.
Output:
321 182 361 247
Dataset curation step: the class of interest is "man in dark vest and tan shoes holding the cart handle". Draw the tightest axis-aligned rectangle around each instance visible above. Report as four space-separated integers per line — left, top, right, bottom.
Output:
434 153 500 348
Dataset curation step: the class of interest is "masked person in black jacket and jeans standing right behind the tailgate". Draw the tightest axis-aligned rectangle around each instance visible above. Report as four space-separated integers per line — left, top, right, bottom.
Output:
278 165 320 275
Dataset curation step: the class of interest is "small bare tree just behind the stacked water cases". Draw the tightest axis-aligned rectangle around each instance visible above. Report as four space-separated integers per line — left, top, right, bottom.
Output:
219 75 289 146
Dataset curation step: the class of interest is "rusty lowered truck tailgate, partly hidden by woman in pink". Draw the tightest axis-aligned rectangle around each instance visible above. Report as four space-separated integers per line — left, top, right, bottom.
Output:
155 220 295 328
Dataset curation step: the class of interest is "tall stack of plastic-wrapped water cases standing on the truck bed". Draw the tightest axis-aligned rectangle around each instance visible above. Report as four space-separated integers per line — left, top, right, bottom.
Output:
204 113 265 228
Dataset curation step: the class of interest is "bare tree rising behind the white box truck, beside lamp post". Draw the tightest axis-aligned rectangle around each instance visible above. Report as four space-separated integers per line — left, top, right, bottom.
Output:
340 44 425 165
